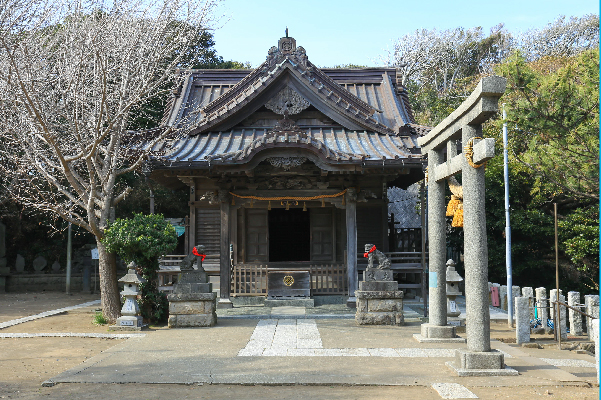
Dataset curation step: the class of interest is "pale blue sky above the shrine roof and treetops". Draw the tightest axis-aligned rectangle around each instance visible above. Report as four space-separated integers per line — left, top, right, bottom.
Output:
210 0 599 67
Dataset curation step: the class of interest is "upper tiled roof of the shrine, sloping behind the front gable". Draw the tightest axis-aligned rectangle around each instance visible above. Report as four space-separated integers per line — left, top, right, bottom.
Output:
163 58 414 134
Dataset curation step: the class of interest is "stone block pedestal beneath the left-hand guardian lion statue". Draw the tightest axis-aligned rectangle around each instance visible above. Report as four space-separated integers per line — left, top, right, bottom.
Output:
167 292 217 328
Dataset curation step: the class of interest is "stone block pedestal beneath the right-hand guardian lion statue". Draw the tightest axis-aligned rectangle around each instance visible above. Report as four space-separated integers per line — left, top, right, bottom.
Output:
355 280 405 325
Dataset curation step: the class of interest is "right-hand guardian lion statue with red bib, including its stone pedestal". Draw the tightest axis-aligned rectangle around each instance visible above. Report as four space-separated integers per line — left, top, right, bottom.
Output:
355 244 405 325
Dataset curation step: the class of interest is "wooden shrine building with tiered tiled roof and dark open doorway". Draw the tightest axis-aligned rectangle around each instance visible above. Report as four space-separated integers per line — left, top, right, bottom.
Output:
145 37 428 306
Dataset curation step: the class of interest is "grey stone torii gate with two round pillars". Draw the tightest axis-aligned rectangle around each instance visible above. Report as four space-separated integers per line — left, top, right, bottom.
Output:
415 76 517 375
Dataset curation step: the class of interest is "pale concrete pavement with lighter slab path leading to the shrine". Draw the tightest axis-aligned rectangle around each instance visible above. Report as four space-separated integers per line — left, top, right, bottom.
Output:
37 304 595 398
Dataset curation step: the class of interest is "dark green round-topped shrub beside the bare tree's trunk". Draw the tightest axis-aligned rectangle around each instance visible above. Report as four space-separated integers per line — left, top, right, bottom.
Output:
102 214 177 323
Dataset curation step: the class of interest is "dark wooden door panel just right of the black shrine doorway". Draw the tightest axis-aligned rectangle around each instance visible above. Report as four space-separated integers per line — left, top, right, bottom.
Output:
309 208 335 261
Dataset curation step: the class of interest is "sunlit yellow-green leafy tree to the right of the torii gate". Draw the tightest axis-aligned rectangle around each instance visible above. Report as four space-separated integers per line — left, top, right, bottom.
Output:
497 49 599 201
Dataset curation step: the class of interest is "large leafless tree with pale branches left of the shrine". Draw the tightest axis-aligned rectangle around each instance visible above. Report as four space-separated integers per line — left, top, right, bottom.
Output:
0 0 219 320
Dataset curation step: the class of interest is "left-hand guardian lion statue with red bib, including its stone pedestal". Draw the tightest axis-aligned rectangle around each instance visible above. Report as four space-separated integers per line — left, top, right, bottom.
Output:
167 246 217 328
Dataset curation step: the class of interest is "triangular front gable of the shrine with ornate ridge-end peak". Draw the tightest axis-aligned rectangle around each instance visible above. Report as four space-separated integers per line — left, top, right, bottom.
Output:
188 37 397 136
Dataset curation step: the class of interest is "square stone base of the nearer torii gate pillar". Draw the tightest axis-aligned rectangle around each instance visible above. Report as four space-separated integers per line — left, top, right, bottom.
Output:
446 349 519 376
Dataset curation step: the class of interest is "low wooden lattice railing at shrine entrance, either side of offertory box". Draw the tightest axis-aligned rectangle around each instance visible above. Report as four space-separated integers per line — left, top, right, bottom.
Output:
231 264 348 296
